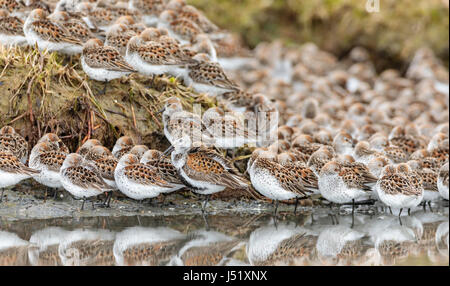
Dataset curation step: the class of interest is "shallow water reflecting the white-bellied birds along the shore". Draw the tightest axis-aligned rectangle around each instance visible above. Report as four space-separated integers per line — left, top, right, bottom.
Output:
0 199 449 265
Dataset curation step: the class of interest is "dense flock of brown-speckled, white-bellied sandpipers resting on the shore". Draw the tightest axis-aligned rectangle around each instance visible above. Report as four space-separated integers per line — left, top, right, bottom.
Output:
0 0 449 219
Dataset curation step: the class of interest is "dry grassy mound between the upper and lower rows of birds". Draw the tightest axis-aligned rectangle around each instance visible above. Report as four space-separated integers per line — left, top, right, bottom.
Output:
0 45 214 150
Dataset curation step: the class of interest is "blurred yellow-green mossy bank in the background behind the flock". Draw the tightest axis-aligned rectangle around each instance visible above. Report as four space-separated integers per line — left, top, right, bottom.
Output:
188 0 449 71
